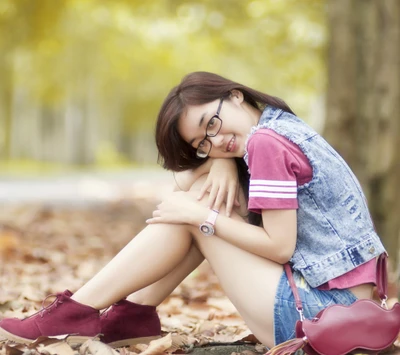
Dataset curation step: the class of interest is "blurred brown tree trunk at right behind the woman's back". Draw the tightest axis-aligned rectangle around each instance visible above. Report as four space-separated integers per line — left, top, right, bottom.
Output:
324 0 400 274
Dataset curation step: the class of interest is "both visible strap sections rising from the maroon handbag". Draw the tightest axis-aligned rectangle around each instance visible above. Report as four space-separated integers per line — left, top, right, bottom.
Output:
284 252 388 314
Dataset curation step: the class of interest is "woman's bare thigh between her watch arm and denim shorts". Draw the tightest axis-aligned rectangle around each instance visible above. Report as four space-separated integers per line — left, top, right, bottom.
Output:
186 184 283 346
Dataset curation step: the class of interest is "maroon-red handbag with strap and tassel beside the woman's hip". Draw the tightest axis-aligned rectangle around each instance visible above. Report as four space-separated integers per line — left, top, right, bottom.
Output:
265 253 400 355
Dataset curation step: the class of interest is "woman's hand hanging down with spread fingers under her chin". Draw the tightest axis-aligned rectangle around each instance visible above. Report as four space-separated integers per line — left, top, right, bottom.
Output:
198 159 239 217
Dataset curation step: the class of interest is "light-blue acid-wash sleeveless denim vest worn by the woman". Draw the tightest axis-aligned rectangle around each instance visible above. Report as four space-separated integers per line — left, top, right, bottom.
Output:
244 106 385 287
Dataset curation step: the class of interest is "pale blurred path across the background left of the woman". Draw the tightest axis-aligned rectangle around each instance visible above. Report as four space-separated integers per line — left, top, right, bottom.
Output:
0 168 173 205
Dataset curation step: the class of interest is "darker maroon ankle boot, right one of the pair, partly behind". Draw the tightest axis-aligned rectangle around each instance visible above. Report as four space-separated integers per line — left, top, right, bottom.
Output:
100 300 161 348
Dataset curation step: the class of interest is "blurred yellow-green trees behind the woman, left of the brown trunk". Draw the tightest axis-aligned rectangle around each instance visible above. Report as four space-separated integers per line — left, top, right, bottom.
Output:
0 0 326 165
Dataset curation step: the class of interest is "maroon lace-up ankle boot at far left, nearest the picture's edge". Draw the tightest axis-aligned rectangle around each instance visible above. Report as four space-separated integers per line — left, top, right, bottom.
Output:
0 290 100 344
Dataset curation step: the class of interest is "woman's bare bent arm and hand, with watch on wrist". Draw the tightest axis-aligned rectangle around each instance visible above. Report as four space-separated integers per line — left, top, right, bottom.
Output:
147 192 297 264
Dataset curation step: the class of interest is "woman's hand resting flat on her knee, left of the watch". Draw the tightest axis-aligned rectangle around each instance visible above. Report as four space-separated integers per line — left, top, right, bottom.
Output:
146 191 209 226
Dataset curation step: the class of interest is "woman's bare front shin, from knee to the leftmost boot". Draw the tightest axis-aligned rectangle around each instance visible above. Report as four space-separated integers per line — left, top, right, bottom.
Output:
72 224 192 309
